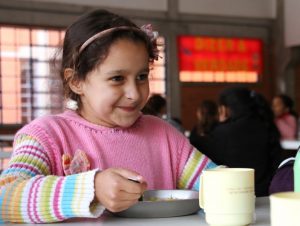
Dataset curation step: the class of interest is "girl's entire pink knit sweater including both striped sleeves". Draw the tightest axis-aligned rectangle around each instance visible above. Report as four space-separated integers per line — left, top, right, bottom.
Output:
0 111 216 223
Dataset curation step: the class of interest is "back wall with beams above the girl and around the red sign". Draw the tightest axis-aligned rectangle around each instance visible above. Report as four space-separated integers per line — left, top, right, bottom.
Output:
0 0 276 131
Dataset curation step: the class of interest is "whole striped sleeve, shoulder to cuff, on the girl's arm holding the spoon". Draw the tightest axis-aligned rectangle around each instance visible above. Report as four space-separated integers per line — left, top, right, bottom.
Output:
0 135 104 223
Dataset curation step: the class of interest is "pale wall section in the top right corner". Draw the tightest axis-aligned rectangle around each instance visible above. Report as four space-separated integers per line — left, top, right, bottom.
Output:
284 0 300 47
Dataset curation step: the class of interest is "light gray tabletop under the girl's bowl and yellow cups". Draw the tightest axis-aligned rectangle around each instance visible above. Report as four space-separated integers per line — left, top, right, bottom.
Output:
2 197 272 226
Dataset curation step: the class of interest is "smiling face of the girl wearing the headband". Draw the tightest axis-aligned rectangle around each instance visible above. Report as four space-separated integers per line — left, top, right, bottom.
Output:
79 39 149 127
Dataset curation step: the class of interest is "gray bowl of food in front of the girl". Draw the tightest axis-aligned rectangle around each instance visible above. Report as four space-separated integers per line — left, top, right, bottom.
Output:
114 190 200 218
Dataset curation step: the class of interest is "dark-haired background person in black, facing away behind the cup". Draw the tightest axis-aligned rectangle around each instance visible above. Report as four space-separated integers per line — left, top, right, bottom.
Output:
201 87 282 196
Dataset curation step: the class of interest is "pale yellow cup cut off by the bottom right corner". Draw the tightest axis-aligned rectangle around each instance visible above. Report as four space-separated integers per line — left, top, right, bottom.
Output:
270 192 300 226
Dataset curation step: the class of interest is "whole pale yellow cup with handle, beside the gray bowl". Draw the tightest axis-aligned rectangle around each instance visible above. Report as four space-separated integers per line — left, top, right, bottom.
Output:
199 168 255 226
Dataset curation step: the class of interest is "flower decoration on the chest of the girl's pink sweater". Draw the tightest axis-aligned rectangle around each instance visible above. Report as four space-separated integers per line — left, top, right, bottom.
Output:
62 150 90 175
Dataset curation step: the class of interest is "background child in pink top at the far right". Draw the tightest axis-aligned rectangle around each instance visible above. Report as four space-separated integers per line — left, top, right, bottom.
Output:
272 94 298 140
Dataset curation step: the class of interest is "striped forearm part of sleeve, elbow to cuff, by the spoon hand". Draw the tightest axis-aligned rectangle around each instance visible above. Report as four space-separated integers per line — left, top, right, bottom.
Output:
0 170 105 223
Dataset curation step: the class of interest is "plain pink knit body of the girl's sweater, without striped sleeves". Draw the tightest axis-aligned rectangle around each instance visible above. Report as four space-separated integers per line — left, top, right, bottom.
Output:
19 111 193 189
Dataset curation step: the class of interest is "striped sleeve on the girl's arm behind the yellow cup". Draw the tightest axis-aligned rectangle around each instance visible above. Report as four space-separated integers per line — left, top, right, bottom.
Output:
177 148 217 190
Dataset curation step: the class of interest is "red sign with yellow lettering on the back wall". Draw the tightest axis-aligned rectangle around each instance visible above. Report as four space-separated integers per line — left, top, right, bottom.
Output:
178 36 263 83
